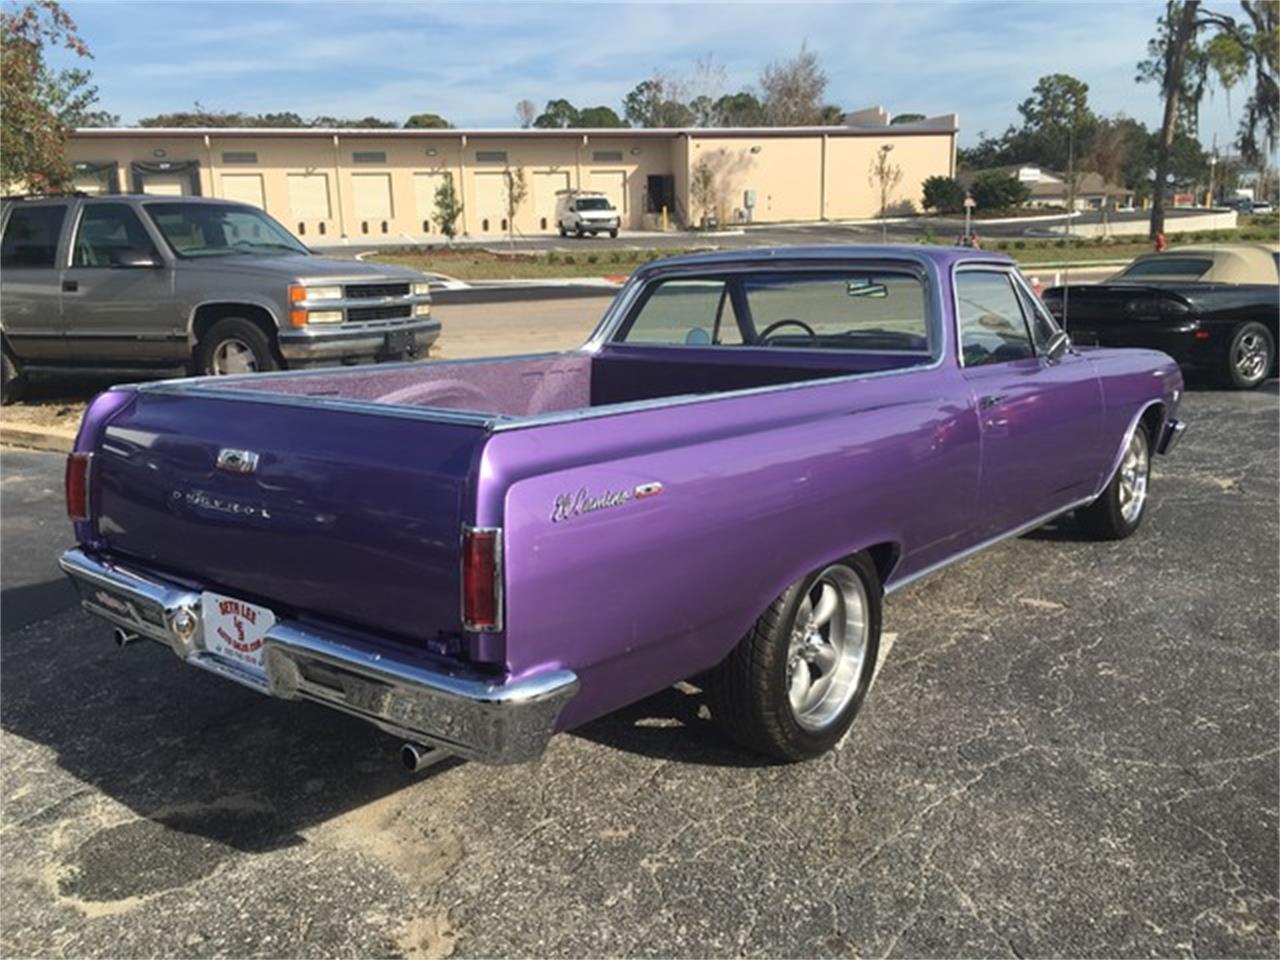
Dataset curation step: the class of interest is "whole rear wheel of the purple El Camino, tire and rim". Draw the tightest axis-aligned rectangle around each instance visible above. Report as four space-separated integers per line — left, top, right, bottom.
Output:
707 554 881 763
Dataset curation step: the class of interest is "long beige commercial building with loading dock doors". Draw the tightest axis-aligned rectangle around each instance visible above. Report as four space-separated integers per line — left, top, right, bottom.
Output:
69 110 956 243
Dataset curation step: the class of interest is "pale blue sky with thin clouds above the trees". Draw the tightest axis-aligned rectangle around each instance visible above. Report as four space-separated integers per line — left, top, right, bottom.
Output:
65 0 1245 147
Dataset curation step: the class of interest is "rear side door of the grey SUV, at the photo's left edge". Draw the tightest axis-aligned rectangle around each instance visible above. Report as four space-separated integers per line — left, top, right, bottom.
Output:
0 200 70 364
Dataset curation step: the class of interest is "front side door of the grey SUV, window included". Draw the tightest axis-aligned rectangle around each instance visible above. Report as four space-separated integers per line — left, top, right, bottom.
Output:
61 201 187 365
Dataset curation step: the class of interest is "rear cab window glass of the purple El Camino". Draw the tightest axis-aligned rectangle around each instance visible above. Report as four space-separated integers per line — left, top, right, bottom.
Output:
612 268 937 362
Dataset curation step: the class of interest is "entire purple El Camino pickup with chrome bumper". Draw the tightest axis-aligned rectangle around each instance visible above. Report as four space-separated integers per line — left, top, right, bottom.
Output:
61 247 1183 769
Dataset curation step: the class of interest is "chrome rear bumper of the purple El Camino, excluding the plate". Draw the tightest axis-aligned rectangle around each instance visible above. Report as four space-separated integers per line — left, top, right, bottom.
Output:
59 549 577 764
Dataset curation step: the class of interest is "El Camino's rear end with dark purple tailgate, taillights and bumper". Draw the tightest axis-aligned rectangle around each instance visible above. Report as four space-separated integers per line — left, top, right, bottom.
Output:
61 384 577 767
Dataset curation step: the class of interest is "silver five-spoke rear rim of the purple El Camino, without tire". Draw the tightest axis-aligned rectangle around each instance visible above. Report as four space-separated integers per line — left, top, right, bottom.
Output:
787 566 870 732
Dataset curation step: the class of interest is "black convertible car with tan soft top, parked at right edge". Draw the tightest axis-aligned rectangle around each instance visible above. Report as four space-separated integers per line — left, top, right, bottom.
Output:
1044 243 1280 390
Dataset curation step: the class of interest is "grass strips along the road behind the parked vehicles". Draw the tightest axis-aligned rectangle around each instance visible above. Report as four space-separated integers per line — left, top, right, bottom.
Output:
369 216 1277 280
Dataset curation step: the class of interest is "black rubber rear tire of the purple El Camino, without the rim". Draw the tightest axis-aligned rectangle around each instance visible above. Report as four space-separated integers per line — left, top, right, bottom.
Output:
707 554 881 763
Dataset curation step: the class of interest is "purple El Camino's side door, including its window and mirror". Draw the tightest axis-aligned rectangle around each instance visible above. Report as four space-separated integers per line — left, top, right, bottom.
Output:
955 266 1102 535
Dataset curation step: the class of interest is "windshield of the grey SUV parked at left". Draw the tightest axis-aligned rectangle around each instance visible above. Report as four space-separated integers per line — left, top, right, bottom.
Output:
146 202 307 259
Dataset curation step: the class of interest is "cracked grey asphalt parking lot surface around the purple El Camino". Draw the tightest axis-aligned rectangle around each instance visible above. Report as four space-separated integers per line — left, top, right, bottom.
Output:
0 381 1280 956
